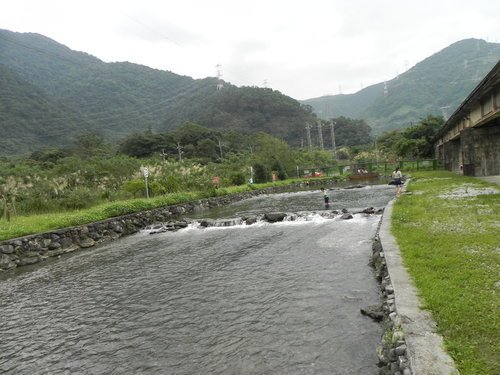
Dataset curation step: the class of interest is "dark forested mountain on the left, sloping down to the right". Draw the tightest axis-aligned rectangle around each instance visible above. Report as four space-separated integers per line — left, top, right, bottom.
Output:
0 30 314 155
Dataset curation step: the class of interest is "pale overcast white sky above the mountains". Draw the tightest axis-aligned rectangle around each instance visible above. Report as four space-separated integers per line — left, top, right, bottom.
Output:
0 0 500 99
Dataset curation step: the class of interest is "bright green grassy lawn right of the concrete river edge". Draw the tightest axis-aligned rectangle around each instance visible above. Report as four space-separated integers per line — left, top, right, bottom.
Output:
392 171 500 375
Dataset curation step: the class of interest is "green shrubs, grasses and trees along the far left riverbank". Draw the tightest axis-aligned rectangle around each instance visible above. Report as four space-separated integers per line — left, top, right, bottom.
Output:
0 116 443 240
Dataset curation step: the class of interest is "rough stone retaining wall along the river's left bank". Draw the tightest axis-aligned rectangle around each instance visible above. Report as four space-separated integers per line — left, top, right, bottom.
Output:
0 180 333 271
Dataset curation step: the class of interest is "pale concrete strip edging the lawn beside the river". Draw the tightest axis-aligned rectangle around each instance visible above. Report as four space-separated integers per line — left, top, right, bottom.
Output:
379 200 458 375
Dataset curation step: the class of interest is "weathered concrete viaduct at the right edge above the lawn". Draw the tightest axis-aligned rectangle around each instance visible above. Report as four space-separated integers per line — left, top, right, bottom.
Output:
433 61 500 177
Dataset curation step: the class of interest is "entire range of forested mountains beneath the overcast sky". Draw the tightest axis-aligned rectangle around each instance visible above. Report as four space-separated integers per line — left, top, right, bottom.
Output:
0 29 500 156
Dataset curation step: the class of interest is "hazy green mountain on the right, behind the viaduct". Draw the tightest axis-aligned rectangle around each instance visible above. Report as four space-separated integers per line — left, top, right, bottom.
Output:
302 39 500 133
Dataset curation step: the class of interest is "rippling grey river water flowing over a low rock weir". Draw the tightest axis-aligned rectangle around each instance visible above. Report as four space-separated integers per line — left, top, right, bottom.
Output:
0 185 393 375
